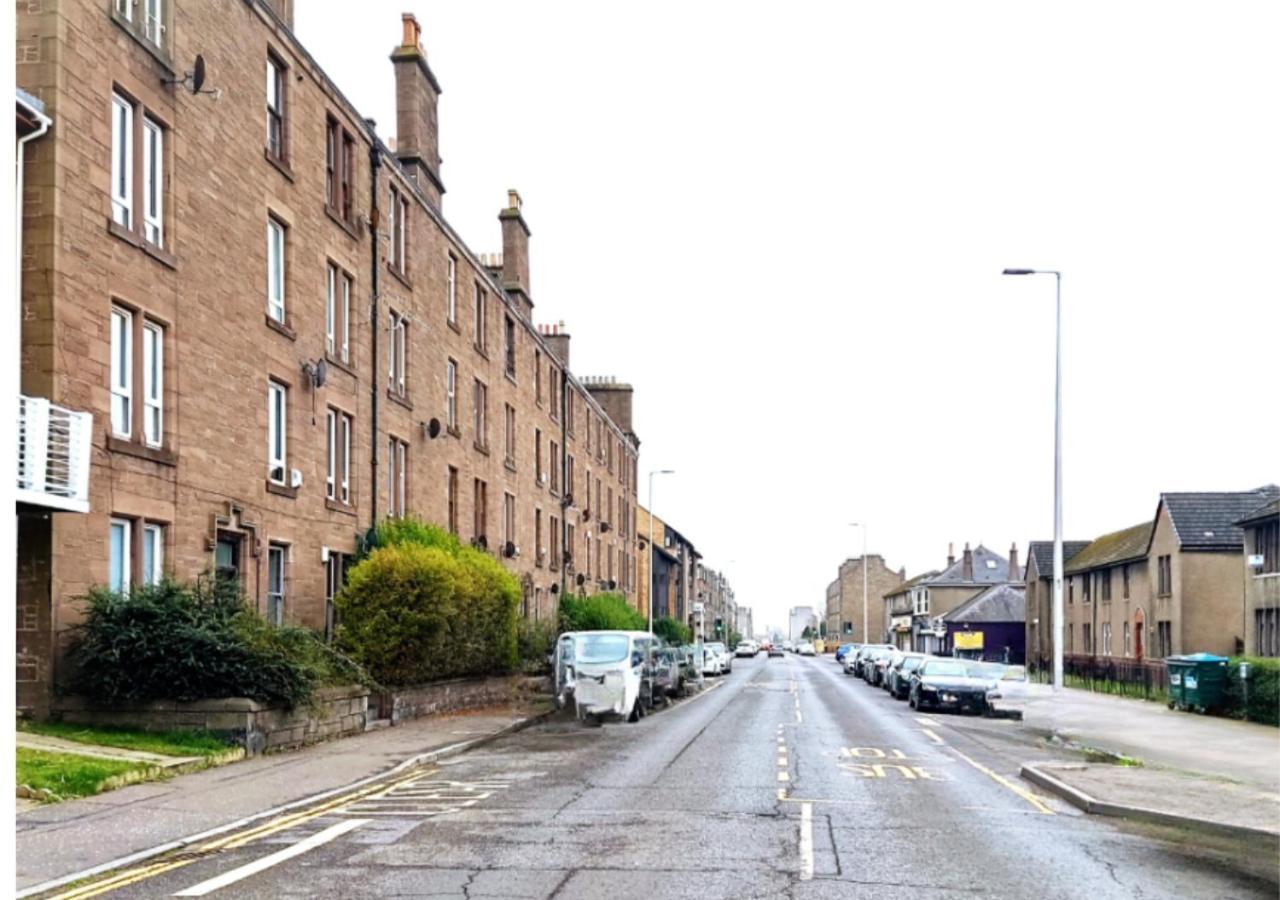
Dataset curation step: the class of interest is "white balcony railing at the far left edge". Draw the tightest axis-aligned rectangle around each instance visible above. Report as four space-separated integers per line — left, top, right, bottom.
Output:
18 394 93 512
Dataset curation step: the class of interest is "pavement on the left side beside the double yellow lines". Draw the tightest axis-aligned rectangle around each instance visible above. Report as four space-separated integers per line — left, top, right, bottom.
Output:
17 707 545 891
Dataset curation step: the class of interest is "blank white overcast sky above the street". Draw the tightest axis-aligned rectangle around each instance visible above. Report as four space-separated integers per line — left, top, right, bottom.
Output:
297 0 1280 630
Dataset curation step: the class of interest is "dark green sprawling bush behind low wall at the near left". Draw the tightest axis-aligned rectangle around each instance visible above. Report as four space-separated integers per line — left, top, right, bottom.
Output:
68 580 367 707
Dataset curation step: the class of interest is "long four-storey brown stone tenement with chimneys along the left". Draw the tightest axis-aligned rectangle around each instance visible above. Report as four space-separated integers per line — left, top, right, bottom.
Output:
17 0 639 707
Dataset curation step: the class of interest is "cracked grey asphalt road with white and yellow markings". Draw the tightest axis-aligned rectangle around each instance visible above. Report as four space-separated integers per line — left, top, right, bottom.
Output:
64 655 1277 900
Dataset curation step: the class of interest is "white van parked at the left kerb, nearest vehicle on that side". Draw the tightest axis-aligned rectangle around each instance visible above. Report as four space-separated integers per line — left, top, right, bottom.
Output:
556 631 660 722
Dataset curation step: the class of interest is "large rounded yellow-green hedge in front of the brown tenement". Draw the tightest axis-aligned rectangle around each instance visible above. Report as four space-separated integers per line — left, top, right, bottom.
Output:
334 520 520 685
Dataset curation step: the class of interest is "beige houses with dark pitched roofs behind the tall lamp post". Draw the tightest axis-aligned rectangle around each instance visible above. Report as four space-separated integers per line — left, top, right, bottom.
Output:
1025 485 1280 666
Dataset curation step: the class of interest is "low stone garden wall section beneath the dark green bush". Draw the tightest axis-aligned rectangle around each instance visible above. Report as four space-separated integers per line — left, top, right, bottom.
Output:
54 686 369 755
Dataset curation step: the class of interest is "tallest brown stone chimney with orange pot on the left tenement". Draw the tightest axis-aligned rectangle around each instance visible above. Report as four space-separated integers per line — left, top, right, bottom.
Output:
392 13 444 209
